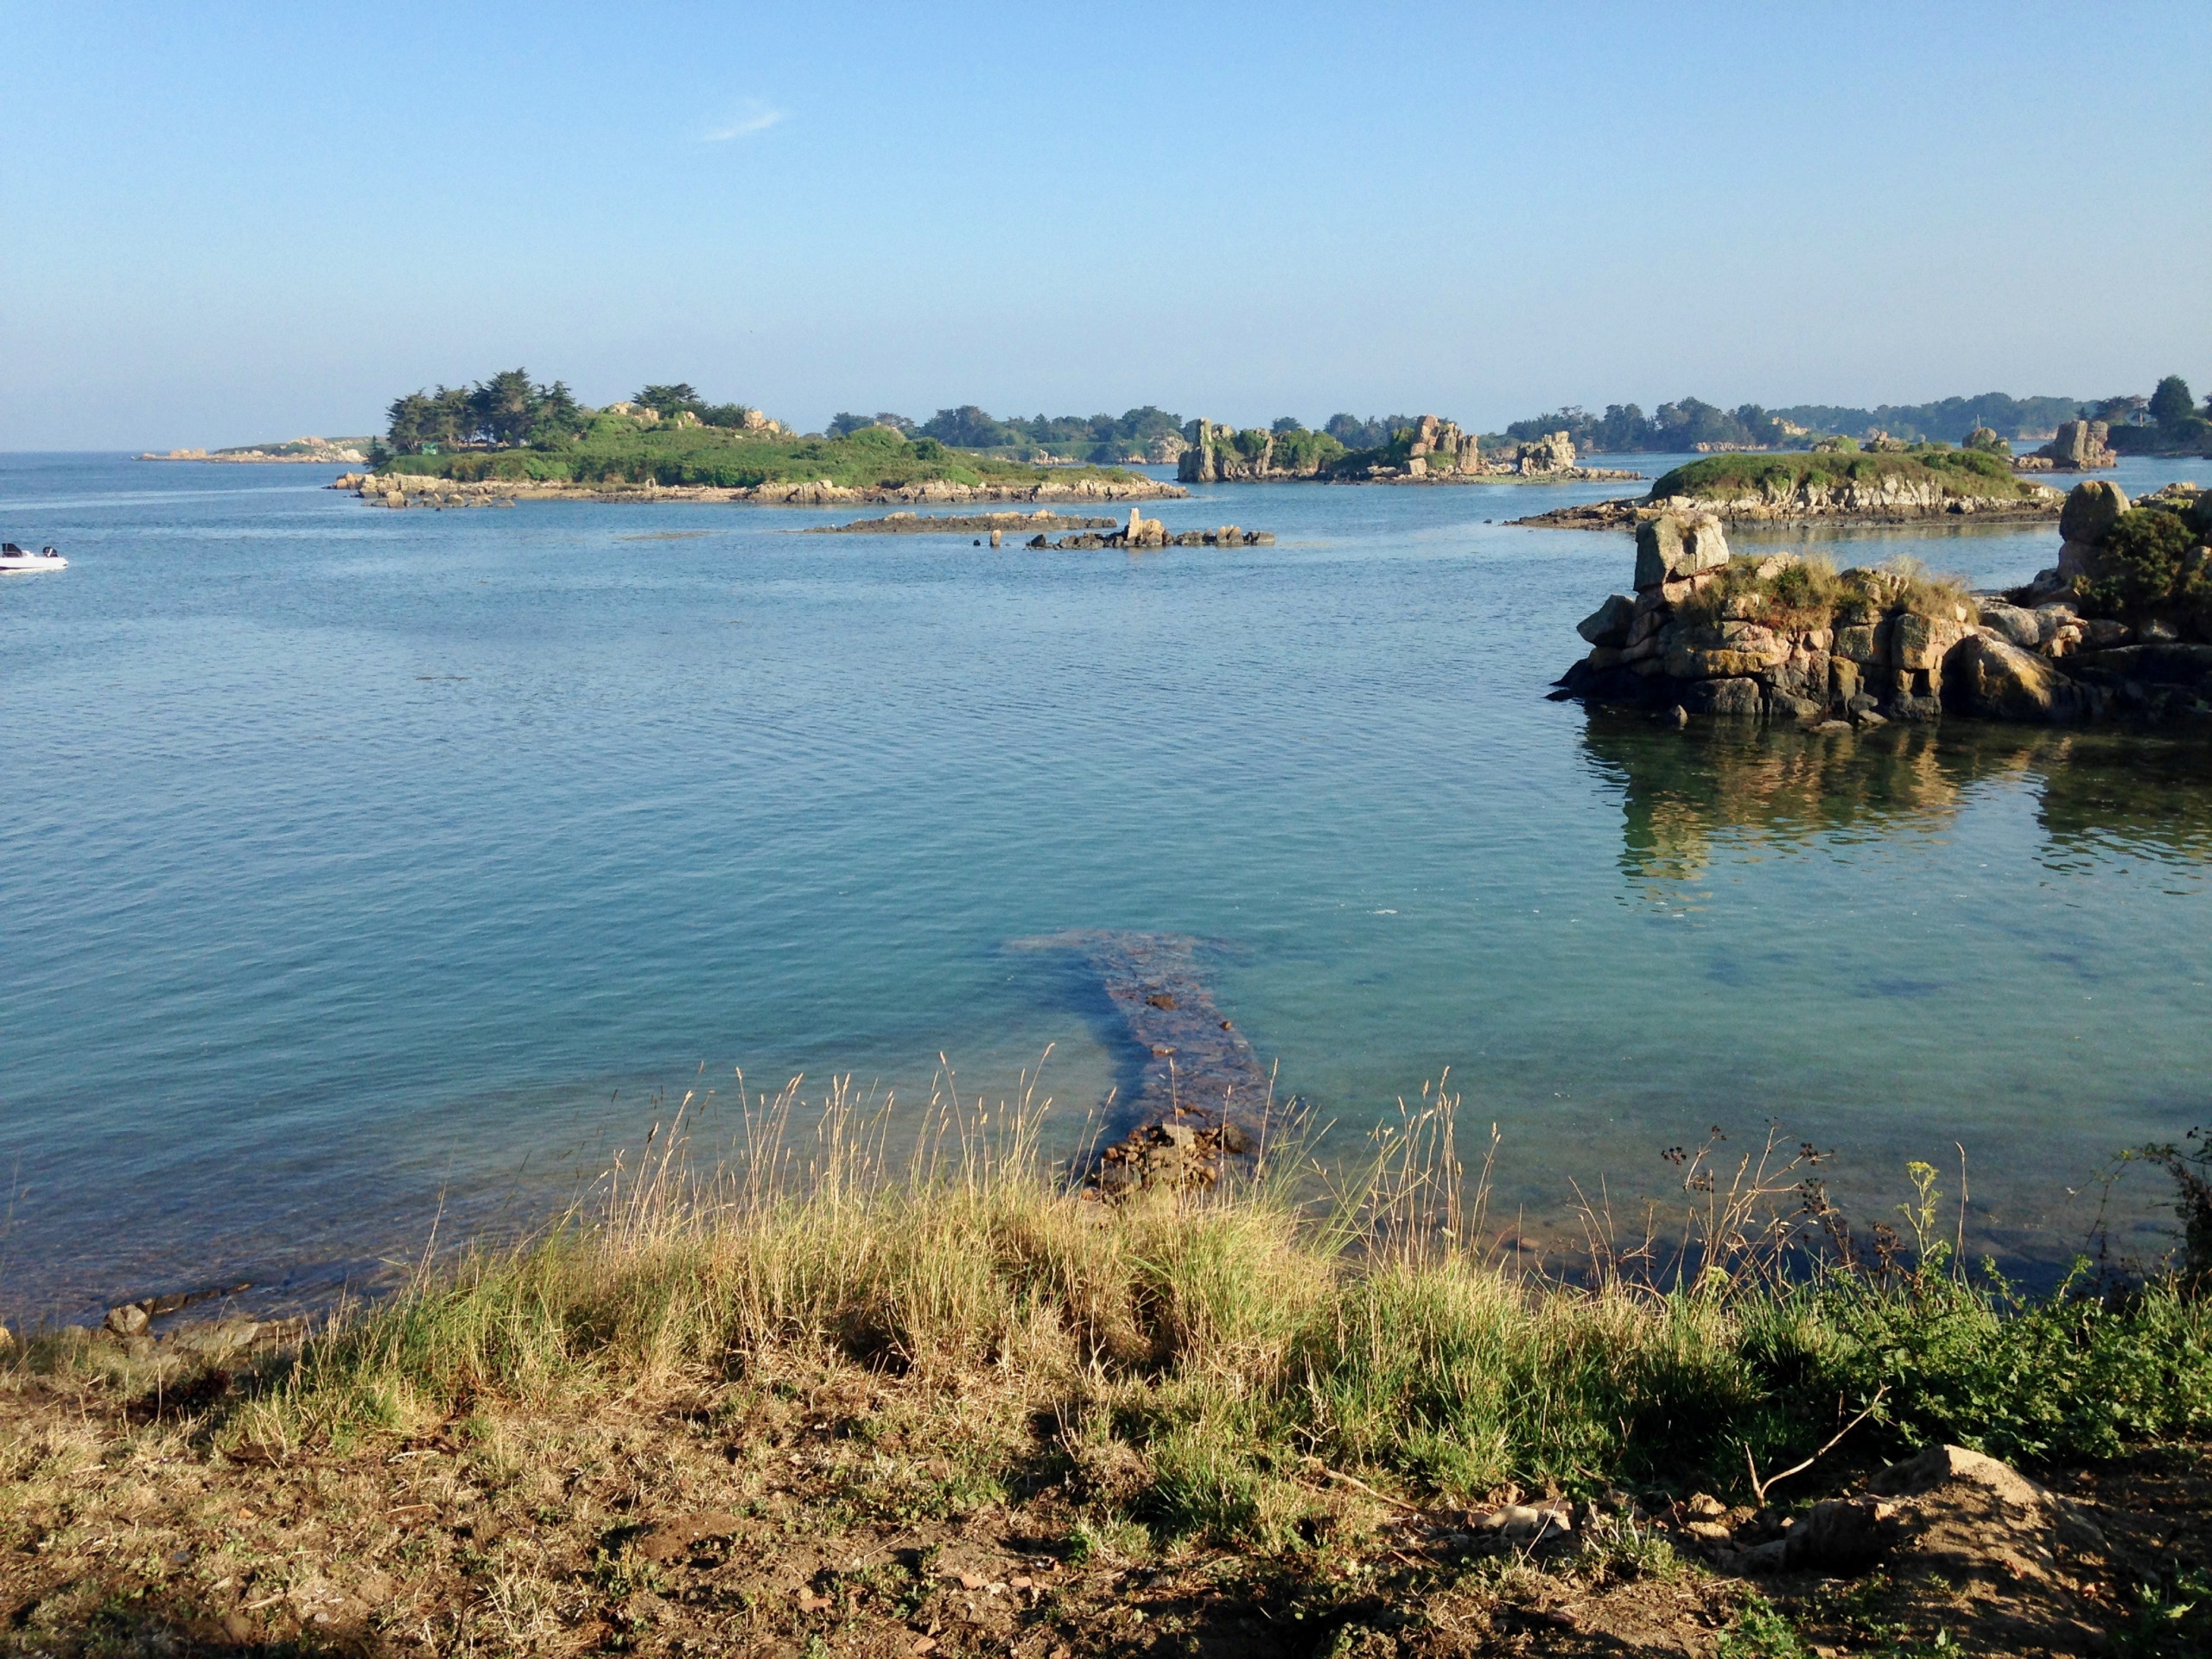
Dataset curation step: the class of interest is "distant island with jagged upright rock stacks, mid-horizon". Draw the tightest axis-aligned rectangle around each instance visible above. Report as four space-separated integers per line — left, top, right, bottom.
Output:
1174 416 1643 485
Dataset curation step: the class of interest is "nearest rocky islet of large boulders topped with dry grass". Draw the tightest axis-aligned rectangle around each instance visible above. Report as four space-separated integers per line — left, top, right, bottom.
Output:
1557 480 2212 730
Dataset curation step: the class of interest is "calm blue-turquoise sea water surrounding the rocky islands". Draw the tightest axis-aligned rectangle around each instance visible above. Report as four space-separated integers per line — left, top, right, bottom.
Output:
0 455 2212 1316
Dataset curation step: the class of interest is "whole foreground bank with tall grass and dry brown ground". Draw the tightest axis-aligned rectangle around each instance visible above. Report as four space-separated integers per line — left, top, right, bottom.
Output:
0 1097 2212 1659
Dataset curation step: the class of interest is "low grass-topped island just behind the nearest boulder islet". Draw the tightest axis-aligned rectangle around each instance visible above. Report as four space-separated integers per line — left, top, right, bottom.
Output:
1513 442 2066 531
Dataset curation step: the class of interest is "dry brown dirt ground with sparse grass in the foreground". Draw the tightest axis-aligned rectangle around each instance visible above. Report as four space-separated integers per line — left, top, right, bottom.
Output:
0 1365 2212 1659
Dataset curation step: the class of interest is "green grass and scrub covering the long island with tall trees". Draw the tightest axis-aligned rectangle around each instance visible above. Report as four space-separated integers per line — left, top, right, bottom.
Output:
383 414 1133 489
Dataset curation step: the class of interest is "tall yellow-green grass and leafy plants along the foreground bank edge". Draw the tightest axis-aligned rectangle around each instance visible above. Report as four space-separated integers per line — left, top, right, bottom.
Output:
39 1095 2212 1544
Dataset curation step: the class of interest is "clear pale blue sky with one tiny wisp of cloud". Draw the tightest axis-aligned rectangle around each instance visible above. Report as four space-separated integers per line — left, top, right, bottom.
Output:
0 0 2212 449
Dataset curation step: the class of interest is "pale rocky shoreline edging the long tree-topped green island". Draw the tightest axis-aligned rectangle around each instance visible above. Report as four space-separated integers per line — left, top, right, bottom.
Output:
329 474 1190 509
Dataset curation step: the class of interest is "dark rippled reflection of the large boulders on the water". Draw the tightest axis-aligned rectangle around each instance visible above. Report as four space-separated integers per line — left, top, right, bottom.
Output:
1584 710 2212 902
